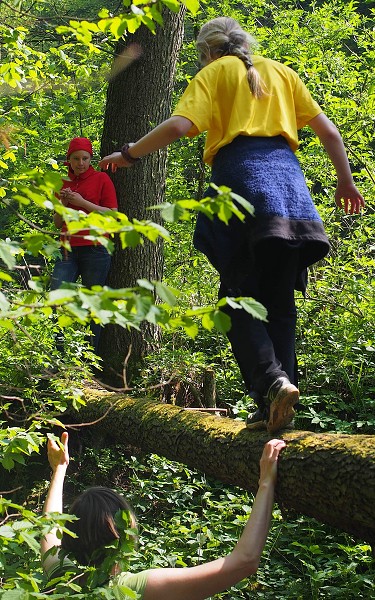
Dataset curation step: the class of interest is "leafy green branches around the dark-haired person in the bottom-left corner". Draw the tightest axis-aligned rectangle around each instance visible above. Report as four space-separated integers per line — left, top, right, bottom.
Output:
0 498 138 600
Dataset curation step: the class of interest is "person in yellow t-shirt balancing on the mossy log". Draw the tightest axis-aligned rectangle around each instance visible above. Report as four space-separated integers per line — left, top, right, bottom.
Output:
100 17 364 433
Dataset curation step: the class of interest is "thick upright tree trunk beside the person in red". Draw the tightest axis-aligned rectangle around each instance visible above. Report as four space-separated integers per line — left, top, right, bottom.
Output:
100 9 184 371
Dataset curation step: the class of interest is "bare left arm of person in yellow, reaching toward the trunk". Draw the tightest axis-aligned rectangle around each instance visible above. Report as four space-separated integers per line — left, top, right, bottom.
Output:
99 116 192 171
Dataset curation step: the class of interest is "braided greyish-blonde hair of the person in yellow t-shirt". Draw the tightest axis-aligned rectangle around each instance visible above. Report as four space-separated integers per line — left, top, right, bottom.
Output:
196 17 264 98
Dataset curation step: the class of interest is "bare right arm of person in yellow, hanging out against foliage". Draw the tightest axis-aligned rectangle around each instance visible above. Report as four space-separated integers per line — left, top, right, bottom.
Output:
309 113 365 214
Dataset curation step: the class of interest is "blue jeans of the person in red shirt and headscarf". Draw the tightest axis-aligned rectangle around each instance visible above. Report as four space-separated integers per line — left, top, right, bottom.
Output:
50 245 111 352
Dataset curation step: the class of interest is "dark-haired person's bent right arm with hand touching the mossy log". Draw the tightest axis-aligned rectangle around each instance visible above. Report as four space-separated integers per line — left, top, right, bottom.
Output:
144 440 285 600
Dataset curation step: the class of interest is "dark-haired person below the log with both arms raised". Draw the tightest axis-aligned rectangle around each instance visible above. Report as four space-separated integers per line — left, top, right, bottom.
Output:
40 432 285 600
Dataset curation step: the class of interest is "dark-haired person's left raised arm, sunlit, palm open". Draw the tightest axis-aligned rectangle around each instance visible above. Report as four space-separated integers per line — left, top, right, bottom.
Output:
40 431 69 569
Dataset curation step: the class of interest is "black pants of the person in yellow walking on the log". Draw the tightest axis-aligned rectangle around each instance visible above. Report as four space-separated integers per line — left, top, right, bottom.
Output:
219 239 299 406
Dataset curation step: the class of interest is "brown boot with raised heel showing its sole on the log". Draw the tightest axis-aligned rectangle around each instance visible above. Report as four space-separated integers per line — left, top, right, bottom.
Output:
267 377 299 433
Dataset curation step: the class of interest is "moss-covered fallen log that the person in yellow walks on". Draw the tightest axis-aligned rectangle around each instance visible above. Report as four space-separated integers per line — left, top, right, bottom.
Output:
71 390 375 545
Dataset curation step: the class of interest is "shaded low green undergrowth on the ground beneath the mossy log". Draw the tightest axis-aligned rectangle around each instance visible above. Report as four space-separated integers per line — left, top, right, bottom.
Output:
39 446 374 600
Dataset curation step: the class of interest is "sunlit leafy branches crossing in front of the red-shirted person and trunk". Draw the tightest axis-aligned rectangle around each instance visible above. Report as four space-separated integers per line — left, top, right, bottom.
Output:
0 170 265 337
